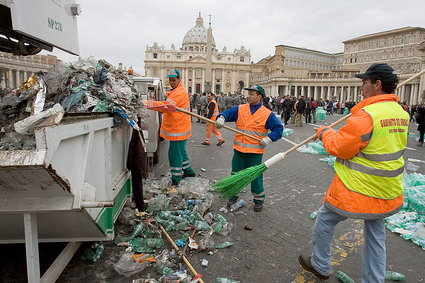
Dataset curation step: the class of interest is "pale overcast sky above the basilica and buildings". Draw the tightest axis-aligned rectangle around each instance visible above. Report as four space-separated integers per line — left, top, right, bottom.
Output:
48 0 425 74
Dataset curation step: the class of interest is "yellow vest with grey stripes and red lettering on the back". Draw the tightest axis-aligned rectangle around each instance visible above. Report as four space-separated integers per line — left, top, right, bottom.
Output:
335 101 409 200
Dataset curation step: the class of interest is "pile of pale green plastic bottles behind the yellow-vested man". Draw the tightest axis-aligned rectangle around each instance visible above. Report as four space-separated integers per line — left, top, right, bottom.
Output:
385 173 425 250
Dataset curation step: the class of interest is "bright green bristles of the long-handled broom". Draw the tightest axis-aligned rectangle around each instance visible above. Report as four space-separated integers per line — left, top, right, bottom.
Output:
212 163 267 199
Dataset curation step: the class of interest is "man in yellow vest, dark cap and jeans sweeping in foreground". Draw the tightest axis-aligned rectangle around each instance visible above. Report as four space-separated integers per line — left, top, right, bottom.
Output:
298 64 409 283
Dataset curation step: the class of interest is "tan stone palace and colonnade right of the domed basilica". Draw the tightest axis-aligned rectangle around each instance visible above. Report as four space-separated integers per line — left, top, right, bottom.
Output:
250 27 425 105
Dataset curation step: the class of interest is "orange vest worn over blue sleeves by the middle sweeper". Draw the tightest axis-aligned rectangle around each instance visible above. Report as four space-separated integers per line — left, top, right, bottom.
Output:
233 103 271 154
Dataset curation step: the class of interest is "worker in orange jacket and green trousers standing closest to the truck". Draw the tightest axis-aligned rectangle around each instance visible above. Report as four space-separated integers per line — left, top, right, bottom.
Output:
146 69 196 186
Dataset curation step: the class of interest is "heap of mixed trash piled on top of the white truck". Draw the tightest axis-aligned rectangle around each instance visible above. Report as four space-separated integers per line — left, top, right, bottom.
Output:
0 57 149 150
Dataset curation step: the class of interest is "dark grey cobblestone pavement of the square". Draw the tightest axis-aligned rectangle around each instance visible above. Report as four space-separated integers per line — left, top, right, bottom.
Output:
0 115 425 283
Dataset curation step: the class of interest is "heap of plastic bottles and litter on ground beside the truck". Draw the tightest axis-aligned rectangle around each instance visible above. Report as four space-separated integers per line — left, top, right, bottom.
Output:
88 177 239 282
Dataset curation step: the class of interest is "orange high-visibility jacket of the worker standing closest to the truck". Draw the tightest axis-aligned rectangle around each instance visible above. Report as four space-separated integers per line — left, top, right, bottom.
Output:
146 82 192 141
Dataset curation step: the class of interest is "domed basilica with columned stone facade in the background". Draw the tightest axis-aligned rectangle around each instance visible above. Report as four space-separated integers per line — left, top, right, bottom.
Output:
145 14 251 93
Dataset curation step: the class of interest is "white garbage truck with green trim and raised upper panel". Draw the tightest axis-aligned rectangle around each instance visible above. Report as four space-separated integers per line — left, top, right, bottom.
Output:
0 0 149 282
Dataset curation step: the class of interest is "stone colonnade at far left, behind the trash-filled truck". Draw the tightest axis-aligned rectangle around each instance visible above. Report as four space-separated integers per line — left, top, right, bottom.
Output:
0 52 60 89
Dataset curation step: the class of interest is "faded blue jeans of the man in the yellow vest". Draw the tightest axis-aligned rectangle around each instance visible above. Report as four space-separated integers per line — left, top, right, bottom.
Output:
311 206 386 283
